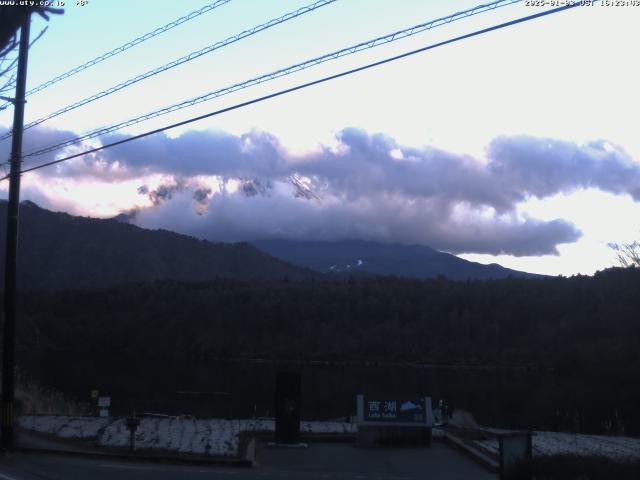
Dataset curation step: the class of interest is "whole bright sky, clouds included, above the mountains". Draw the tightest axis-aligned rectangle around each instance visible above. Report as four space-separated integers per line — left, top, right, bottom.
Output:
0 0 640 276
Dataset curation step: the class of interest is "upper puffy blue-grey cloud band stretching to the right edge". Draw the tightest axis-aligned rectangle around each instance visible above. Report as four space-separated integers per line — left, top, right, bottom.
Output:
32 128 640 204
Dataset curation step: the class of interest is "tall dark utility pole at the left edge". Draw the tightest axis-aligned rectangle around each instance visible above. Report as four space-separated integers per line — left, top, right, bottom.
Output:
2 13 31 448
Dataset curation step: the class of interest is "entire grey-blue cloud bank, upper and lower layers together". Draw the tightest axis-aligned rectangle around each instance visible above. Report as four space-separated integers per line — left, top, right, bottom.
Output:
18 128 640 255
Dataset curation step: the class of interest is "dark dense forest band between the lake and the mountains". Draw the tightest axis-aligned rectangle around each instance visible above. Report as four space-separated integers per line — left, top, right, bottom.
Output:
10 268 640 434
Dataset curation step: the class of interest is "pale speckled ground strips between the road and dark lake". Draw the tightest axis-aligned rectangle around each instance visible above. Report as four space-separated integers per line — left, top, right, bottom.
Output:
22 414 640 460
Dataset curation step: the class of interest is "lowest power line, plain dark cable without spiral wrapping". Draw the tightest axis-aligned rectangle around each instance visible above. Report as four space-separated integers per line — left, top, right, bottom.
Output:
0 3 580 181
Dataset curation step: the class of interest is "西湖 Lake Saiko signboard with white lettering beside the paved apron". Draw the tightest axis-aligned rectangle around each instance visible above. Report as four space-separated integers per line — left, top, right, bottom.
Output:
358 395 433 427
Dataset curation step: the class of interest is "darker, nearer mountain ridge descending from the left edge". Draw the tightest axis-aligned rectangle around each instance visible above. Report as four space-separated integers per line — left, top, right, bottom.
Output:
0 201 314 289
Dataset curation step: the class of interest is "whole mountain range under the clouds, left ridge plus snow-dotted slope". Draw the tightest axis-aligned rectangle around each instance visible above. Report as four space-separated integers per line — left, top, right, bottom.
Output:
0 201 542 290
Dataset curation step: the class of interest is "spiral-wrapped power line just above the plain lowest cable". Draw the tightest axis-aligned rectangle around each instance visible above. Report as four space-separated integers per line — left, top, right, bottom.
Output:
24 0 521 158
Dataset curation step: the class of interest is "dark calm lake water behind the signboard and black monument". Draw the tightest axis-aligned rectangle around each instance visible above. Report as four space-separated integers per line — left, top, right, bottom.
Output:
22 355 542 419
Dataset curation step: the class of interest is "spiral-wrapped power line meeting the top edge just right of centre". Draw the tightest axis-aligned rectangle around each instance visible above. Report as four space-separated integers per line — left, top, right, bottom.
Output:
0 0 336 140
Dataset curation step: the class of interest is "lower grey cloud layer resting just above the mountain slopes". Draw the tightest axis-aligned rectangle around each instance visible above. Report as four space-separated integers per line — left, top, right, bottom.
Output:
129 189 580 256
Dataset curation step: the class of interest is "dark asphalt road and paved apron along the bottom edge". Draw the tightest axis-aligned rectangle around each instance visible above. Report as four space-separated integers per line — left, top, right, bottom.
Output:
0 443 497 480
